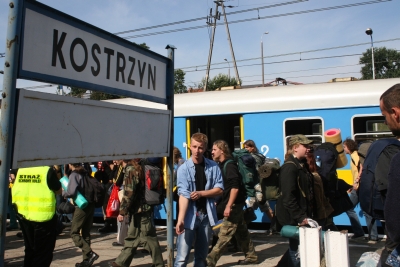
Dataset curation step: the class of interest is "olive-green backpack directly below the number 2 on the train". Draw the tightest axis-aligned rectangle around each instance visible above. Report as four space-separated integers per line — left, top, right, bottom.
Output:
258 158 281 201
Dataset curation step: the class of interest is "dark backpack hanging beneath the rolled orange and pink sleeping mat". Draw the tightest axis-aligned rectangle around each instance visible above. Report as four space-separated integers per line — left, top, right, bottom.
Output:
314 142 339 197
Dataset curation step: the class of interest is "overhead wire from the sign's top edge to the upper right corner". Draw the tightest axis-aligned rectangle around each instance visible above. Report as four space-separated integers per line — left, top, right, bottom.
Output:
123 0 392 39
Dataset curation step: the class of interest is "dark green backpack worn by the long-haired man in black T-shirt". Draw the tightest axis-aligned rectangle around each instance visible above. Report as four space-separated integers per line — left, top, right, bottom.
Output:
232 149 259 197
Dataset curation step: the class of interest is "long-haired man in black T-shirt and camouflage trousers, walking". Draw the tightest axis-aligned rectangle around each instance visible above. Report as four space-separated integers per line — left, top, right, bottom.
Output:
207 140 258 267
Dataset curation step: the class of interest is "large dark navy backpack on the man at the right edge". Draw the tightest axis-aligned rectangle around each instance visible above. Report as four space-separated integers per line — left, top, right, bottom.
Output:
358 138 400 220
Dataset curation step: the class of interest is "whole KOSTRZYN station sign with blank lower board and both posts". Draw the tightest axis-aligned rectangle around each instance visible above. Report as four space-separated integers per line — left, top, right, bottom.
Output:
0 0 174 267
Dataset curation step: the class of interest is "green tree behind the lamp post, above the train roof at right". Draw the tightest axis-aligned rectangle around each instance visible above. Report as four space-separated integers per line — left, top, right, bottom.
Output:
360 47 400 80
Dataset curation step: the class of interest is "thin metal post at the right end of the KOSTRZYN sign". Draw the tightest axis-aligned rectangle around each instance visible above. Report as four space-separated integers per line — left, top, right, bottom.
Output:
165 45 176 267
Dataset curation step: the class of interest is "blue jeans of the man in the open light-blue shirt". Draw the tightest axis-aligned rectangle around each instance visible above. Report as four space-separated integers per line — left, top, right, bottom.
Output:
174 212 211 267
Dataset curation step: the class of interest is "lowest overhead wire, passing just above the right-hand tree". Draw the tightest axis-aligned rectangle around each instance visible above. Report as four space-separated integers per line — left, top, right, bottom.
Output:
178 38 400 72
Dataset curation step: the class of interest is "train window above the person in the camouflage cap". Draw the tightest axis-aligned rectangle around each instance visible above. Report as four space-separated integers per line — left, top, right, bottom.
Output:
284 118 323 151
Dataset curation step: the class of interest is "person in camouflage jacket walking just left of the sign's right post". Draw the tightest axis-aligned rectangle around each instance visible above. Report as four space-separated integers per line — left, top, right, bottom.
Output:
109 160 164 267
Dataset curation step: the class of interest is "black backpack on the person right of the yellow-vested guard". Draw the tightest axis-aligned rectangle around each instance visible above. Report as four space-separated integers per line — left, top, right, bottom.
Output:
83 173 106 208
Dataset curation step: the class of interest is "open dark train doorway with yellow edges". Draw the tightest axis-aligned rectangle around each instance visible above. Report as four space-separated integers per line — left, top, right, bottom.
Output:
187 115 243 156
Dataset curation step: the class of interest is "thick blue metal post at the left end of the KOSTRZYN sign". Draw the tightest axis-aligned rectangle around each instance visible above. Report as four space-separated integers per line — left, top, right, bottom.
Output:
0 0 24 267
